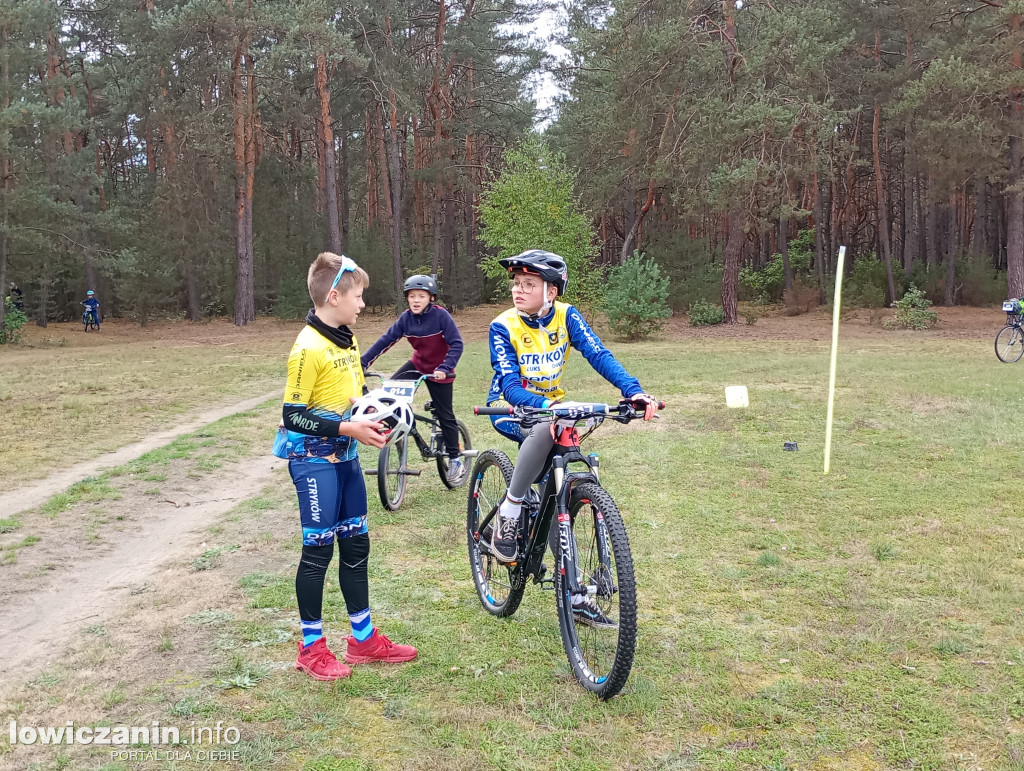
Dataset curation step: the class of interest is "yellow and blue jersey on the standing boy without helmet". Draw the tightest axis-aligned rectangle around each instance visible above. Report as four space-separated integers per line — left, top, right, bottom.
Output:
273 326 364 463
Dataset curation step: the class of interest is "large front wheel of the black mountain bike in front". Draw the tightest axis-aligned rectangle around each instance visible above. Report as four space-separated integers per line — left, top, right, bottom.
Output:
555 482 637 699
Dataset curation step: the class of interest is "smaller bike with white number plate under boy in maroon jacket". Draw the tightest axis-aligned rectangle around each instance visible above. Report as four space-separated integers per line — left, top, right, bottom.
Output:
365 372 476 511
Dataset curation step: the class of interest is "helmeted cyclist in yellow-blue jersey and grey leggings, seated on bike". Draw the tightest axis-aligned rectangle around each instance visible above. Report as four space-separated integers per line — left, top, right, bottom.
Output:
487 249 657 628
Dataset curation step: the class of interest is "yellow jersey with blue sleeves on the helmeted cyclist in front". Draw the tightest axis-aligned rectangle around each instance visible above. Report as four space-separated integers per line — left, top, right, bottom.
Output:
487 302 643 406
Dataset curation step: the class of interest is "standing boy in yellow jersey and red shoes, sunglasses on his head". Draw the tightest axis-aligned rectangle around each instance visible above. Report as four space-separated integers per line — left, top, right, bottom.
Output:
273 252 416 680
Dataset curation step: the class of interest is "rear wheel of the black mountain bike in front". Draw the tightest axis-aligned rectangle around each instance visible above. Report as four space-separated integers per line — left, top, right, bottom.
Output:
466 449 526 618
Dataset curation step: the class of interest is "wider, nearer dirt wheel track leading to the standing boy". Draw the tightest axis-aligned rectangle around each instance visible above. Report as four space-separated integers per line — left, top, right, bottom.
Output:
0 454 285 690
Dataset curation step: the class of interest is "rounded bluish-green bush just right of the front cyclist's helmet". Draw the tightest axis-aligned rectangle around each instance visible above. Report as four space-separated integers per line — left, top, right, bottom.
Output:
604 251 672 340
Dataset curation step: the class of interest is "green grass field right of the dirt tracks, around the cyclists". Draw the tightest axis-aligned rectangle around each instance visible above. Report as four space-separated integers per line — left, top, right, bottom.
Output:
0 311 1024 771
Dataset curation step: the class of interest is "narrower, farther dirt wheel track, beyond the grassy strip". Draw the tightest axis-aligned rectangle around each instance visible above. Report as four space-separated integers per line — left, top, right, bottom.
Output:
0 391 281 517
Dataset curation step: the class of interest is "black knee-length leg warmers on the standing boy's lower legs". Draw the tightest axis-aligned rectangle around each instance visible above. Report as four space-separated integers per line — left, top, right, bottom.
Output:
295 532 370 622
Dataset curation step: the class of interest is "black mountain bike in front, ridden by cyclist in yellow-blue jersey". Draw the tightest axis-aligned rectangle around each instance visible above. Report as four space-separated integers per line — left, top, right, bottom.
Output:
466 401 664 699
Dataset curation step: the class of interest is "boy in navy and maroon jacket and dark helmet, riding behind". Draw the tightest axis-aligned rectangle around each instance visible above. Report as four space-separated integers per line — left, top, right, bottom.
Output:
362 275 465 484
